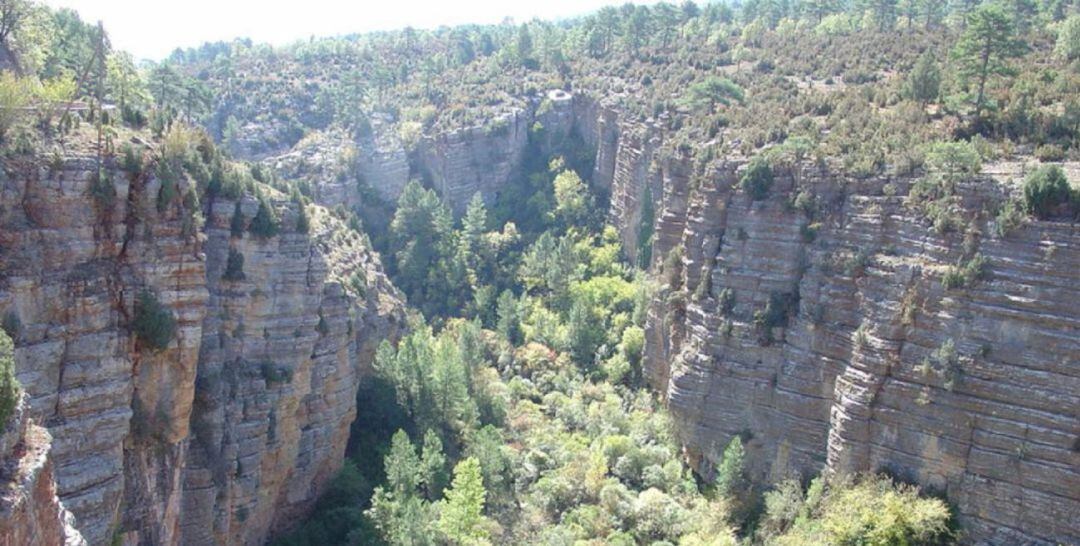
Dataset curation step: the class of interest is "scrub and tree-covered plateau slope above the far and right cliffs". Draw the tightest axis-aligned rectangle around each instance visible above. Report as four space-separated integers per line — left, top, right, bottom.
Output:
162 0 1080 175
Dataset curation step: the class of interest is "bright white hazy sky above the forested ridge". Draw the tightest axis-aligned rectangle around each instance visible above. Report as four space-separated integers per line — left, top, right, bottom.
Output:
45 0 649 59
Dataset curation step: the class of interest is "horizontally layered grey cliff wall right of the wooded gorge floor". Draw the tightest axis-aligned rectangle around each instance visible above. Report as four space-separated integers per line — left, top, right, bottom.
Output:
575 97 1080 545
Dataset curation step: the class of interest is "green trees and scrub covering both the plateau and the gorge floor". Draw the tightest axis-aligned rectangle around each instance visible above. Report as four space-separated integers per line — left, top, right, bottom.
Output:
0 0 1080 545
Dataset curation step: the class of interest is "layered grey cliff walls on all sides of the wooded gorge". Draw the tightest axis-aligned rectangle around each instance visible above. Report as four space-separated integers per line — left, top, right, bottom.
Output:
0 92 1080 545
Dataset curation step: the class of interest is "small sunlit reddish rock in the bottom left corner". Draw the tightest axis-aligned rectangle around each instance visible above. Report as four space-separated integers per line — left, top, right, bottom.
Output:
0 397 86 546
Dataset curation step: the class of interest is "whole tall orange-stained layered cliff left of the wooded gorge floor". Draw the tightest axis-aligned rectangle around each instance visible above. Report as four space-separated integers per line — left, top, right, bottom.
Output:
0 136 401 545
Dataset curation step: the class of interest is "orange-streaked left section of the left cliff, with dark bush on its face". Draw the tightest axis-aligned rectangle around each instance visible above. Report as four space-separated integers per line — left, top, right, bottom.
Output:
0 137 207 544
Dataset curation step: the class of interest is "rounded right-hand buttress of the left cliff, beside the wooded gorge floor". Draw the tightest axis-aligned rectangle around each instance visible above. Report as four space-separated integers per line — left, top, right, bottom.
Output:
183 194 404 544
